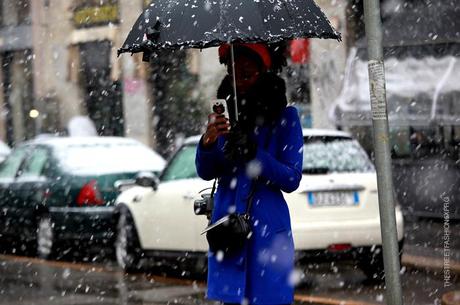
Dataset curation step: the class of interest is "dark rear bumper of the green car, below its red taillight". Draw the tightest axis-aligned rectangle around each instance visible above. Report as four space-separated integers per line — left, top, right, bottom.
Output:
50 207 115 241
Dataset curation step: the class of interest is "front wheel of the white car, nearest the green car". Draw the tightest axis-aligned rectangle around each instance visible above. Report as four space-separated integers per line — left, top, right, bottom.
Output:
115 211 141 271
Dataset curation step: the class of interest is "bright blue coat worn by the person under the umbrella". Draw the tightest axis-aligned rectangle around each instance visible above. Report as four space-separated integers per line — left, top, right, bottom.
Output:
196 107 303 304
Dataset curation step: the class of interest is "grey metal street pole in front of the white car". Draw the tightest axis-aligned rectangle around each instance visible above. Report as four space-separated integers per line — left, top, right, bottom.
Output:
363 0 403 305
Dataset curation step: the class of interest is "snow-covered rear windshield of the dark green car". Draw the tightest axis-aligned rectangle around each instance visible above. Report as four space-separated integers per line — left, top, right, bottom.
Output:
55 142 165 175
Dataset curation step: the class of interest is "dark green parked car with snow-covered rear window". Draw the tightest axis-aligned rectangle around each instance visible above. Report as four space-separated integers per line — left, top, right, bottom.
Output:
0 137 166 258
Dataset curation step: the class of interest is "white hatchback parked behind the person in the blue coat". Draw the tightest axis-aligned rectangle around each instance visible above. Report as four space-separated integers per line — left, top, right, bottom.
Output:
115 129 403 278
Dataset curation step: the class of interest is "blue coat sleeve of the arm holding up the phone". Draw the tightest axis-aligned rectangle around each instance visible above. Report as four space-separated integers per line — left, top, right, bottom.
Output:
195 138 224 180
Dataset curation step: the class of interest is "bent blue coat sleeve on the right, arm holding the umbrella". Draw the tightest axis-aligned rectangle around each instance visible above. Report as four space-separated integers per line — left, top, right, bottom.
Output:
256 107 303 193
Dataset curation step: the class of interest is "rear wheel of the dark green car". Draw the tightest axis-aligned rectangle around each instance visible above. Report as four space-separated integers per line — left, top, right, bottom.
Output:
36 215 56 259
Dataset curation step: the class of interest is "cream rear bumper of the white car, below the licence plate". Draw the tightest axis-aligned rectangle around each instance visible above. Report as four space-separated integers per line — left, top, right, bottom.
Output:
292 209 404 251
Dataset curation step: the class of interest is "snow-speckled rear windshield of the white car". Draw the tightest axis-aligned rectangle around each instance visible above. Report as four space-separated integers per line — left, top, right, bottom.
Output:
303 137 374 174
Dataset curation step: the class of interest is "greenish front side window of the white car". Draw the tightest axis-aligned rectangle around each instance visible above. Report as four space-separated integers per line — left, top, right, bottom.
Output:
161 145 198 181
